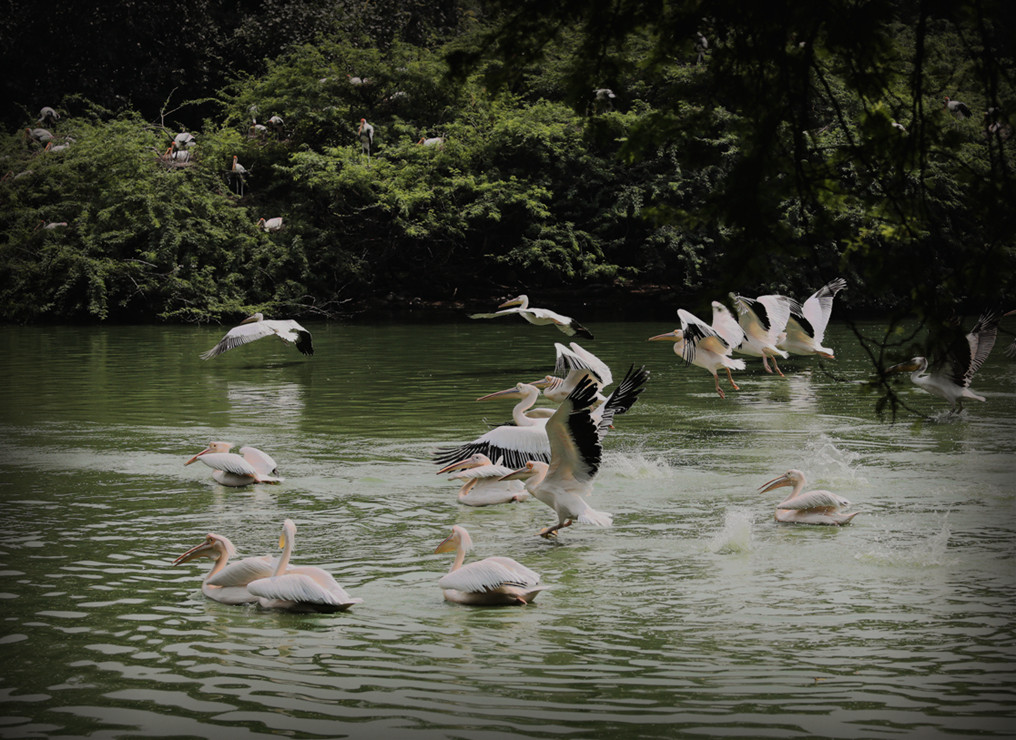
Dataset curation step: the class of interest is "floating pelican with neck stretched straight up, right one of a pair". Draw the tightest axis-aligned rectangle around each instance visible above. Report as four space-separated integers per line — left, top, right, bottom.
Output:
247 519 364 612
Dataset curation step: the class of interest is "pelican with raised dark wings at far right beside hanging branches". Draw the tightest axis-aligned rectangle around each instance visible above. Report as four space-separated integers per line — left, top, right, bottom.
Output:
886 313 999 412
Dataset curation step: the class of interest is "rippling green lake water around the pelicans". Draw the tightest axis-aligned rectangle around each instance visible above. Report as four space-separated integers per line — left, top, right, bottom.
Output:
0 319 1016 739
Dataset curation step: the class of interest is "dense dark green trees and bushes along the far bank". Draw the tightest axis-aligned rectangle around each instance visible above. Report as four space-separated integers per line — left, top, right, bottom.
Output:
0 0 1016 363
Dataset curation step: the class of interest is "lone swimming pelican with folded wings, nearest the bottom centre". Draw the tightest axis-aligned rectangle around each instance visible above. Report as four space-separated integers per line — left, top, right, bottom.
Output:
434 525 547 606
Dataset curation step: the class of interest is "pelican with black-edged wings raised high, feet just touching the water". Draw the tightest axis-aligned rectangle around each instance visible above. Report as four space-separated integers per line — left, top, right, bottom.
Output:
502 378 613 538
